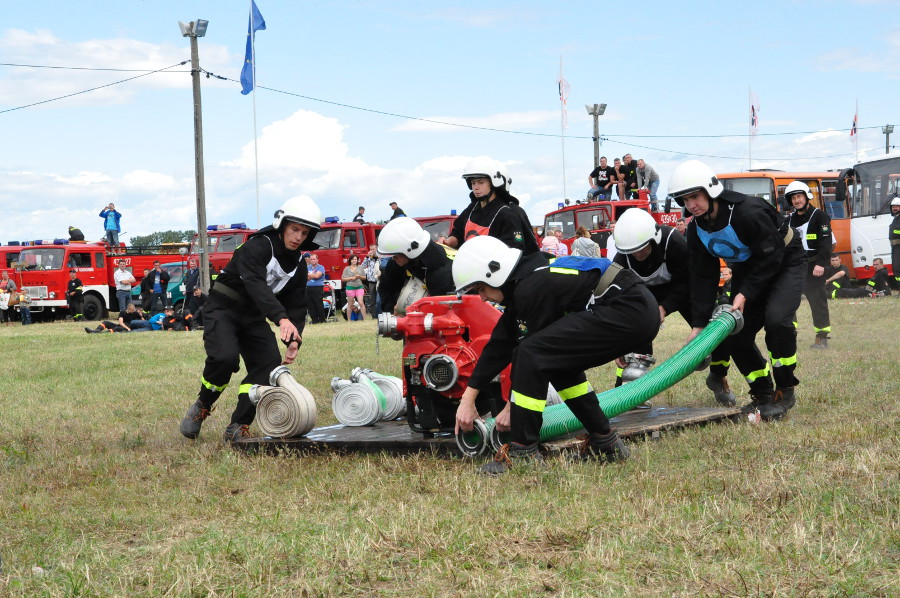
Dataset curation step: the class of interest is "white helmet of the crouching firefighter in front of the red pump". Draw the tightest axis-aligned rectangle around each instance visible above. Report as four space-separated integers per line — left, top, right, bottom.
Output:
453 235 522 293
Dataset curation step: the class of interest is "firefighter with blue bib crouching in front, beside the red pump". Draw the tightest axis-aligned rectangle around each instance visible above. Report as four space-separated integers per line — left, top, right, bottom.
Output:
453 237 659 475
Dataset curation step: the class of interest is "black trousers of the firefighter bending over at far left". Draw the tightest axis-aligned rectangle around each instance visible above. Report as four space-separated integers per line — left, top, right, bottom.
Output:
198 293 303 425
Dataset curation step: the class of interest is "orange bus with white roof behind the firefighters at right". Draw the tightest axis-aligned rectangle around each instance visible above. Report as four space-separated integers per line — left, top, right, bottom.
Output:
716 170 852 276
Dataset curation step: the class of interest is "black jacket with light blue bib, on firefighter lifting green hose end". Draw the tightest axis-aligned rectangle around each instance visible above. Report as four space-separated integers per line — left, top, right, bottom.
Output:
687 191 805 327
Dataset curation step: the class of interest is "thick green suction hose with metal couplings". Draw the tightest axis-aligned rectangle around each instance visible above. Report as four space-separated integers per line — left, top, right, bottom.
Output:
456 305 744 457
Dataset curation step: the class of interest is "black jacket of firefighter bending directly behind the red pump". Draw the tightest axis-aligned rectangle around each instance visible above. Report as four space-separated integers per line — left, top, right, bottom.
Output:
378 241 456 313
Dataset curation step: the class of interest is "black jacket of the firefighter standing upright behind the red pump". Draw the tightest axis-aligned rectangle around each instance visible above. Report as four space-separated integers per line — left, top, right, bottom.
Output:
450 190 540 255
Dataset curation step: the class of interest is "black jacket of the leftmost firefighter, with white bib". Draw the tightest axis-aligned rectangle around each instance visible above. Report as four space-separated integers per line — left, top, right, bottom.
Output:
213 226 317 330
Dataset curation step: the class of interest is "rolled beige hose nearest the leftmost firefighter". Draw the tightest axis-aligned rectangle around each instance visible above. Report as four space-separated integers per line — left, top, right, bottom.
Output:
249 366 318 438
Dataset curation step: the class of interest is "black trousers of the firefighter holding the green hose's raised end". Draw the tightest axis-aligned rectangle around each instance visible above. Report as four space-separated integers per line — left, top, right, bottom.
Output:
720 262 806 395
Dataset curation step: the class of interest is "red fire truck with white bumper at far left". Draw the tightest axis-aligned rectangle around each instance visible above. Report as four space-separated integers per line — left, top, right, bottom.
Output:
10 239 172 320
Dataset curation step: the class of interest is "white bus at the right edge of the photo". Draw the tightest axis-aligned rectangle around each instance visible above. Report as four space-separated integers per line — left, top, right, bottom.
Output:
838 152 900 279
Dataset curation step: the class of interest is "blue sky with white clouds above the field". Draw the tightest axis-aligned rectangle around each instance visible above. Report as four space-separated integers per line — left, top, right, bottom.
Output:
0 0 900 243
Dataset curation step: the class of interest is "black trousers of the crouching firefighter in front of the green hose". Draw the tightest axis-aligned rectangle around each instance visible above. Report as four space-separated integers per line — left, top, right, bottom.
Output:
510 280 659 444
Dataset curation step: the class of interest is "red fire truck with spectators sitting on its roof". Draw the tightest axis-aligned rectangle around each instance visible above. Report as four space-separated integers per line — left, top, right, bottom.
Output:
537 190 681 255
